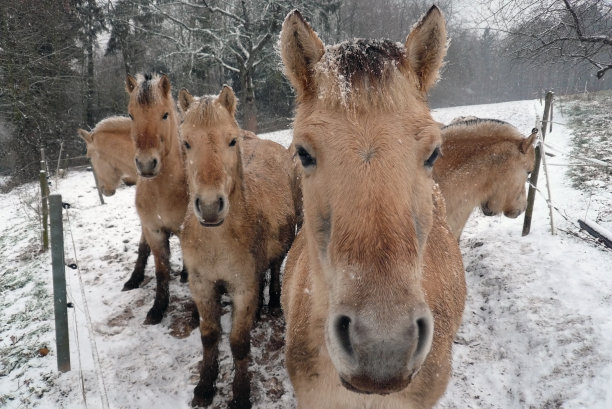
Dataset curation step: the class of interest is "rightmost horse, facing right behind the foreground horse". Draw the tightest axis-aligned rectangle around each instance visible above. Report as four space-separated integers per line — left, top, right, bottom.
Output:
433 118 537 240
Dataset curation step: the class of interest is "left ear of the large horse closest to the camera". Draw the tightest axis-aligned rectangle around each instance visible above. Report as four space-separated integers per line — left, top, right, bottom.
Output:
279 10 325 94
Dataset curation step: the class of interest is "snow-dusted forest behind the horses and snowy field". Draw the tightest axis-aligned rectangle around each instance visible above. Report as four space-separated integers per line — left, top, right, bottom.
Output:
0 0 612 183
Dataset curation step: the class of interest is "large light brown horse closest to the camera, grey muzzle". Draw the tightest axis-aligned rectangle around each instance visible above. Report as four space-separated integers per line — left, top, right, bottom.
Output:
280 6 465 409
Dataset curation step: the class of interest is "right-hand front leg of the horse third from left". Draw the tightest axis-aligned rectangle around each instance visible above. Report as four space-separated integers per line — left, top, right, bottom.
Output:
229 279 259 409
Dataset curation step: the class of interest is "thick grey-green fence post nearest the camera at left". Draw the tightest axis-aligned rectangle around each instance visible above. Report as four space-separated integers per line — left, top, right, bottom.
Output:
49 195 70 372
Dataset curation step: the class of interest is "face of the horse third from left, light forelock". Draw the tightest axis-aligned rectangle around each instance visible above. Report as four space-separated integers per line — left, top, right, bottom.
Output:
179 86 242 227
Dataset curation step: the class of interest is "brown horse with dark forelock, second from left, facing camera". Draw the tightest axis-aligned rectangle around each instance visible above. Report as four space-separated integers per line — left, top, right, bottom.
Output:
126 74 188 324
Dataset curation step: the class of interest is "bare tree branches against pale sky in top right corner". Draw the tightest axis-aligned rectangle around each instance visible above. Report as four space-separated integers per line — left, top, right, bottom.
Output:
488 0 612 79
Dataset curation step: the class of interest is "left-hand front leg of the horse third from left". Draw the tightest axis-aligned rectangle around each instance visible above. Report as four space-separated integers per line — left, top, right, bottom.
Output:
190 283 221 407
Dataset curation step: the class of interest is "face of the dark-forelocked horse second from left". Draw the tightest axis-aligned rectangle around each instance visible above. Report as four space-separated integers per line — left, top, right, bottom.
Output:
126 74 177 178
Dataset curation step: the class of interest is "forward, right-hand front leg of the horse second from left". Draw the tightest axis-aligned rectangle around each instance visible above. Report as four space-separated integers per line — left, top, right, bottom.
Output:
144 230 170 324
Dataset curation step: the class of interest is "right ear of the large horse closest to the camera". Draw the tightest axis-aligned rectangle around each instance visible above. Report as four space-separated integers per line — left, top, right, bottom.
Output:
405 6 447 92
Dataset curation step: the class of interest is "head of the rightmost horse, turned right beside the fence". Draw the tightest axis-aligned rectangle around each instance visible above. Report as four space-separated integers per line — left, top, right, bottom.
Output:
480 133 536 218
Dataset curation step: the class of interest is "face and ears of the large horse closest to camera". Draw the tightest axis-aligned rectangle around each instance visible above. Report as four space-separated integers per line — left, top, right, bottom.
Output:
280 7 446 394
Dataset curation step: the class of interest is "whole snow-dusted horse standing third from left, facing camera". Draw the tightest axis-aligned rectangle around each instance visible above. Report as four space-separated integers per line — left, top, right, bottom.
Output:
179 86 296 408
